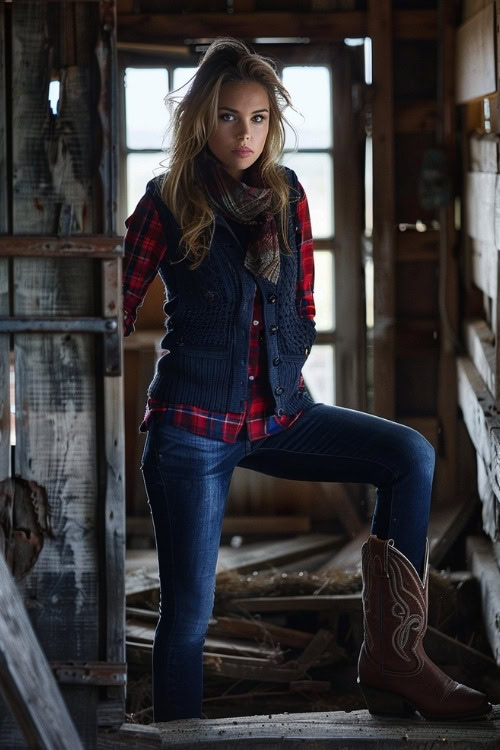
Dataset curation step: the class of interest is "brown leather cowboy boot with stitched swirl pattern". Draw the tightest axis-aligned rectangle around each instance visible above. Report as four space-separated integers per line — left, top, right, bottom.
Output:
358 536 491 720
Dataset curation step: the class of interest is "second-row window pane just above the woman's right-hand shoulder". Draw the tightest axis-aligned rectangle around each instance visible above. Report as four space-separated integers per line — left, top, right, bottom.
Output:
283 153 333 239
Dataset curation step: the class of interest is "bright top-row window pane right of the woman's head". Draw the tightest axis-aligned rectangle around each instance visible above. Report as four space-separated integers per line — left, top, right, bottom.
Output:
283 66 332 148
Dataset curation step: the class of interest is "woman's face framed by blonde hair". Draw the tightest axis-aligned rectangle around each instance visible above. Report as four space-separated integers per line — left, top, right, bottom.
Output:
208 81 269 180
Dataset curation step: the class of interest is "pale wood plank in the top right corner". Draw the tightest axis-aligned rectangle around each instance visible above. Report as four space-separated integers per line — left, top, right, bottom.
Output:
456 3 497 103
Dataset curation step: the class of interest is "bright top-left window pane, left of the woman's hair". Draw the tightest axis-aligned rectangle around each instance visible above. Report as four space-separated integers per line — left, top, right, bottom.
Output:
125 68 168 148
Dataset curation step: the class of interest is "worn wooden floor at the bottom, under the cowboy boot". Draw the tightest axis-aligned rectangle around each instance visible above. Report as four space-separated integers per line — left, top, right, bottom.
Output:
98 705 500 750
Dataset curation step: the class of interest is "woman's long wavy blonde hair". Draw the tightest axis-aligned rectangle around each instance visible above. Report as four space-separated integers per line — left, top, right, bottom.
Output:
160 37 298 269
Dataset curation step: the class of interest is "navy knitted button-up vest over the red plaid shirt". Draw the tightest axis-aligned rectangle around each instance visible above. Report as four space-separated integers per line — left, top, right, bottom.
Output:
146 168 316 416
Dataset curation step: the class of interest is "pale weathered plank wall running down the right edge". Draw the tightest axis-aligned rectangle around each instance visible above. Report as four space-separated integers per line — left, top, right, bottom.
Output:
456 0 500 664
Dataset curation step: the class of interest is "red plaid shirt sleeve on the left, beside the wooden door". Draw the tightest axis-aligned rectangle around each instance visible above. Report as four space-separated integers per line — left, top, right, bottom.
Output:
123 194 167 336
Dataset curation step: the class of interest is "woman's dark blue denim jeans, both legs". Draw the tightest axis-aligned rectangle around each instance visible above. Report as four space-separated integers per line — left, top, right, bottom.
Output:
141 404 435 721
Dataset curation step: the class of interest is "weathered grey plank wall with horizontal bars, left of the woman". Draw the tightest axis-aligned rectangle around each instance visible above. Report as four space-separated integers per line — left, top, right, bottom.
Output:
0 0 126 750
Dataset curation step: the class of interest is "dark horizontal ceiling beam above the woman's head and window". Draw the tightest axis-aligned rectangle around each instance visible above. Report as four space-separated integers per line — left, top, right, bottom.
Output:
118 10 437 44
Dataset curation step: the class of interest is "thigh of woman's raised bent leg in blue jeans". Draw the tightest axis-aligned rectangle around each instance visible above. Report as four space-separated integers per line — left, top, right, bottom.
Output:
238 404 434 487
